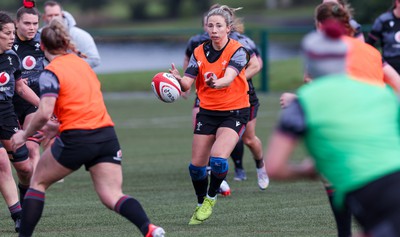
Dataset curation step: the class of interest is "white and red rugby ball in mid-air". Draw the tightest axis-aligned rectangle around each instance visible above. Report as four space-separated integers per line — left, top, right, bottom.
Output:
151 72 182 103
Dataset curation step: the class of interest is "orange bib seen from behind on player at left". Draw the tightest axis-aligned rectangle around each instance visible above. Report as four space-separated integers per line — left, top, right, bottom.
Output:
46 54 114 132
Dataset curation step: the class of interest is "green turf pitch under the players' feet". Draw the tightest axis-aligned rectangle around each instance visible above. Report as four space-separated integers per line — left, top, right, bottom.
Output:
0 92 357 237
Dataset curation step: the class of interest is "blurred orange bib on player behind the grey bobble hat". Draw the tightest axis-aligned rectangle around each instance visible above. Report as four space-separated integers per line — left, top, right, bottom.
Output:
342 36 385 86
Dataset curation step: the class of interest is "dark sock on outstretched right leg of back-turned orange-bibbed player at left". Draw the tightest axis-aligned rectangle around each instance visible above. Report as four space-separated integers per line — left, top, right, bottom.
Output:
114 195 150 236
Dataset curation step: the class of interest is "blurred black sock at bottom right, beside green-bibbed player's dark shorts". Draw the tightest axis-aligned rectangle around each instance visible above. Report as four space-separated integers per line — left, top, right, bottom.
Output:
325 187 351 237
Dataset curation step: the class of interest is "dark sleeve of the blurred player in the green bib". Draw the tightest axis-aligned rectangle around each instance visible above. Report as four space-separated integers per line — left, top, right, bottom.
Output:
277 99 307 137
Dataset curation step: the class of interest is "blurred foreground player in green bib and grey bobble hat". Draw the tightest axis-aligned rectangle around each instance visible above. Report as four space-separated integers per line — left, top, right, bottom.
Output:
265 21 400 237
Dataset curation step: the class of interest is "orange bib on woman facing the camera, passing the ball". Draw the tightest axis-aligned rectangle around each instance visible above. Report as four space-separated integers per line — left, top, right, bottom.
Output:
194 39 250 111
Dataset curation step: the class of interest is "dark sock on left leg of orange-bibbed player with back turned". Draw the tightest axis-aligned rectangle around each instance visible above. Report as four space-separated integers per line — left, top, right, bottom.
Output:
19 188 45 236
